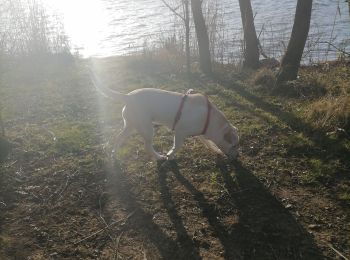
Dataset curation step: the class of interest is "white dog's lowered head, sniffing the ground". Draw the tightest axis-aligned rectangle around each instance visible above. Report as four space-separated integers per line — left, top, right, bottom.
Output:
218 124 239 159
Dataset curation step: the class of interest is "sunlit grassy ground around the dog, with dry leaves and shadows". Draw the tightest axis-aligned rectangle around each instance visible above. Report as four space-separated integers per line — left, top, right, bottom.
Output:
0 56 350 259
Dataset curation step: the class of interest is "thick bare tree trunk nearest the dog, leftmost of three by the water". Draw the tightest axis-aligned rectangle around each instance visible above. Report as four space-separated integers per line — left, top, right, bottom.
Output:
191 0 212 75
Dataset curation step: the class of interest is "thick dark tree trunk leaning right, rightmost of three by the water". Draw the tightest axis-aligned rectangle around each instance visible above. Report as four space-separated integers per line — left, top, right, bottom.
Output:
277 0 312 84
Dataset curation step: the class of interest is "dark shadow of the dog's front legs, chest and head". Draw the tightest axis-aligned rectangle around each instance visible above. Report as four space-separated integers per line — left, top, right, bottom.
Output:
158 161 324 259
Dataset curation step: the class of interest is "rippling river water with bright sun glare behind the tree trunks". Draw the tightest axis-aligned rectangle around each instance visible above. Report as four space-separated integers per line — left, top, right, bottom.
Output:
44 0 350 62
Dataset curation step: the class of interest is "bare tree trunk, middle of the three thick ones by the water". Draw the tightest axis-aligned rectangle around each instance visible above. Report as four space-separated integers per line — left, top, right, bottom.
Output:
239 0 259 69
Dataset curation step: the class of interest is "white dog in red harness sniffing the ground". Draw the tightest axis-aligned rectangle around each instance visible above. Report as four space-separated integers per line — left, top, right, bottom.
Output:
89 70 239 160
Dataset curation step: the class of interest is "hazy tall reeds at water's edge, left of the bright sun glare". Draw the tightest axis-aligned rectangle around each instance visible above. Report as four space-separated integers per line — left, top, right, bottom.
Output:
0 0 70 58
